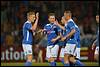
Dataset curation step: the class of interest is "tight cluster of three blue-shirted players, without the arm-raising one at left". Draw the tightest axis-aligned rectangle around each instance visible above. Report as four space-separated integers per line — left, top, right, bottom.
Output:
44 11 84 66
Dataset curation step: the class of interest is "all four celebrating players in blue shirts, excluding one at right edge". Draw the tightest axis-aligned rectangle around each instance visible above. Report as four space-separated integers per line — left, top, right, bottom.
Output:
22 10 99 66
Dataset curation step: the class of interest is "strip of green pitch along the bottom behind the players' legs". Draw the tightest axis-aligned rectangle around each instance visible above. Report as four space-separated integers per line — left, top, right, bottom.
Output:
1 62 99 66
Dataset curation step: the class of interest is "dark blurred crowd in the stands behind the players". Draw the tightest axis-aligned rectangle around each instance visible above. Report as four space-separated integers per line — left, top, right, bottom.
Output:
1 1 98 47
